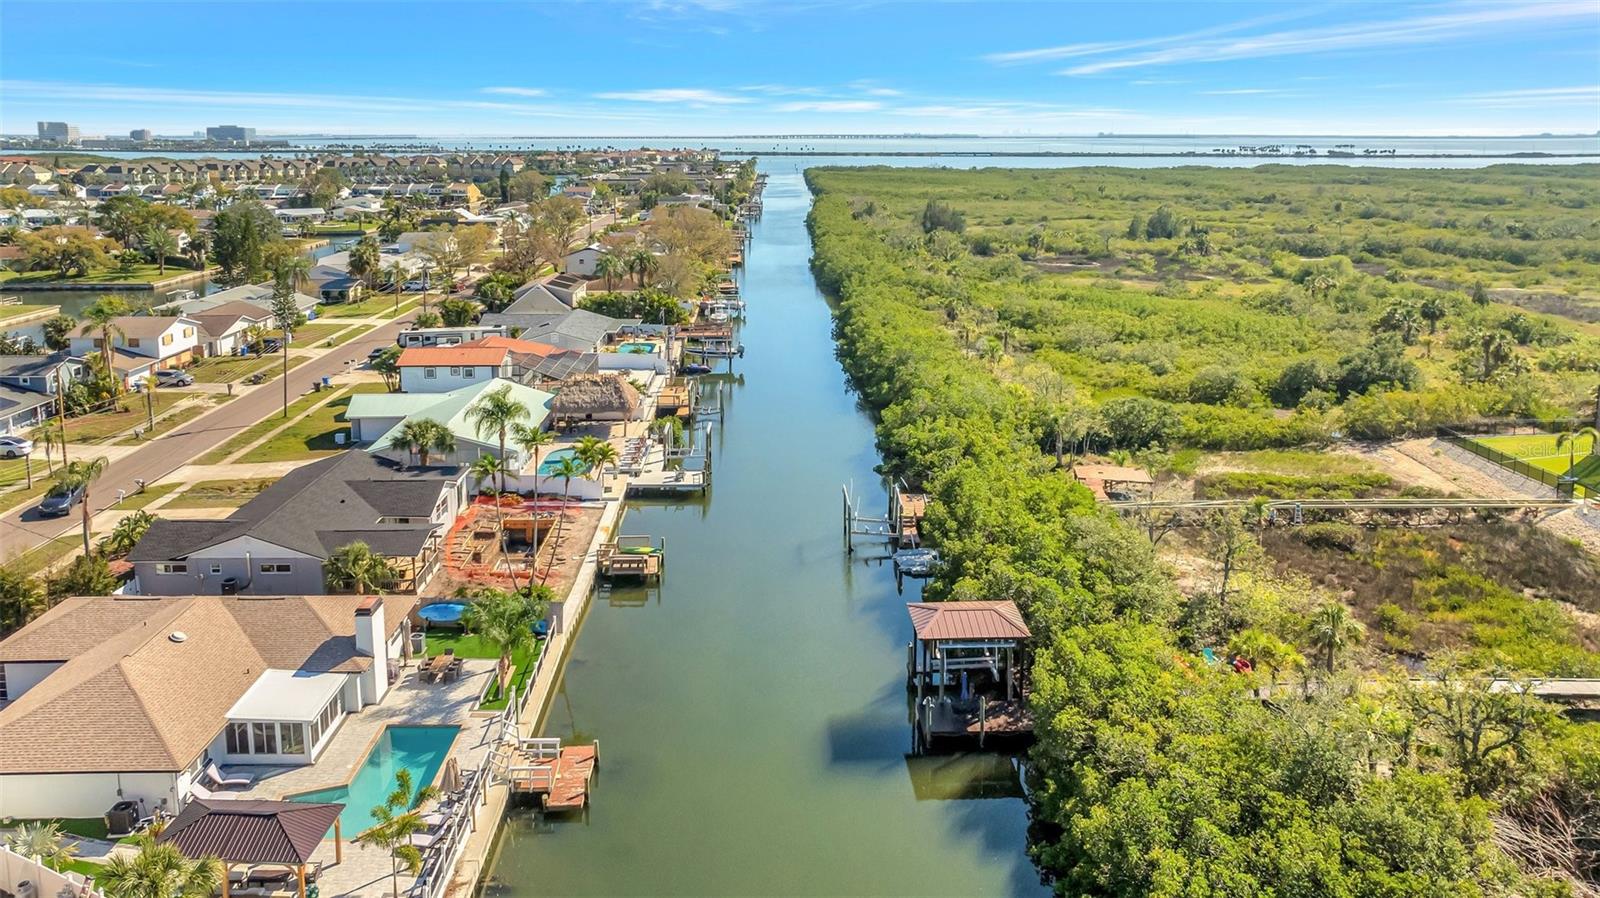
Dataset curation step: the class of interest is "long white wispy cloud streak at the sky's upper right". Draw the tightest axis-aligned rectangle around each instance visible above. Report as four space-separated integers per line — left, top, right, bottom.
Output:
1042 0 1595 75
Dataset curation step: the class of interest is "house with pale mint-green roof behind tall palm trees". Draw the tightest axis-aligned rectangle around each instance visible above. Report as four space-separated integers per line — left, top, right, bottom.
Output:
344 379 552 471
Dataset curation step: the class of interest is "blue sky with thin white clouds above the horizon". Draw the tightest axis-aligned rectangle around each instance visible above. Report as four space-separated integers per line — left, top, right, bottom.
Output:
0 0 1600 136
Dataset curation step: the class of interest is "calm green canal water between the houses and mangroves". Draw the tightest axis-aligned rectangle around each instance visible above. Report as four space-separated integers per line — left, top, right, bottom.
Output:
486 160 1045 898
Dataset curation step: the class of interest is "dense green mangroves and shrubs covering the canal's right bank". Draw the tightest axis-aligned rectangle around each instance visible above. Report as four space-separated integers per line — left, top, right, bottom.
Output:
810 168 1600 898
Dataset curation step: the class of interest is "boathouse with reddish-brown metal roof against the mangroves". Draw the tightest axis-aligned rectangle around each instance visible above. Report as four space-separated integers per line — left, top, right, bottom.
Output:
906 602 1032 701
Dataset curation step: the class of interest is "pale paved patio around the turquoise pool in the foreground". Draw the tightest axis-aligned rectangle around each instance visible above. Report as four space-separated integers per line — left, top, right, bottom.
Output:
227 658 498 898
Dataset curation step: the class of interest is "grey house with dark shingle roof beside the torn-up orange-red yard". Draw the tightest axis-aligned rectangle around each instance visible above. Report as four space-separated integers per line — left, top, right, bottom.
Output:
128 451 467 595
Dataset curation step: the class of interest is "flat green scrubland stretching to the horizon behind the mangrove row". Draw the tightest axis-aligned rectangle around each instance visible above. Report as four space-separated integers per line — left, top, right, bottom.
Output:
814 166 1600 448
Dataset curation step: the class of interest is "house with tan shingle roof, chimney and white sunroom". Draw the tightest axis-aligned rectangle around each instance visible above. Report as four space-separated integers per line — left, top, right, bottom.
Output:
0 595 418 818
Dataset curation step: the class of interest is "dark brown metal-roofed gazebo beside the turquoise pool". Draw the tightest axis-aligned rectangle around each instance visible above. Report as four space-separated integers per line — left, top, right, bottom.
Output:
157 797 344 898
